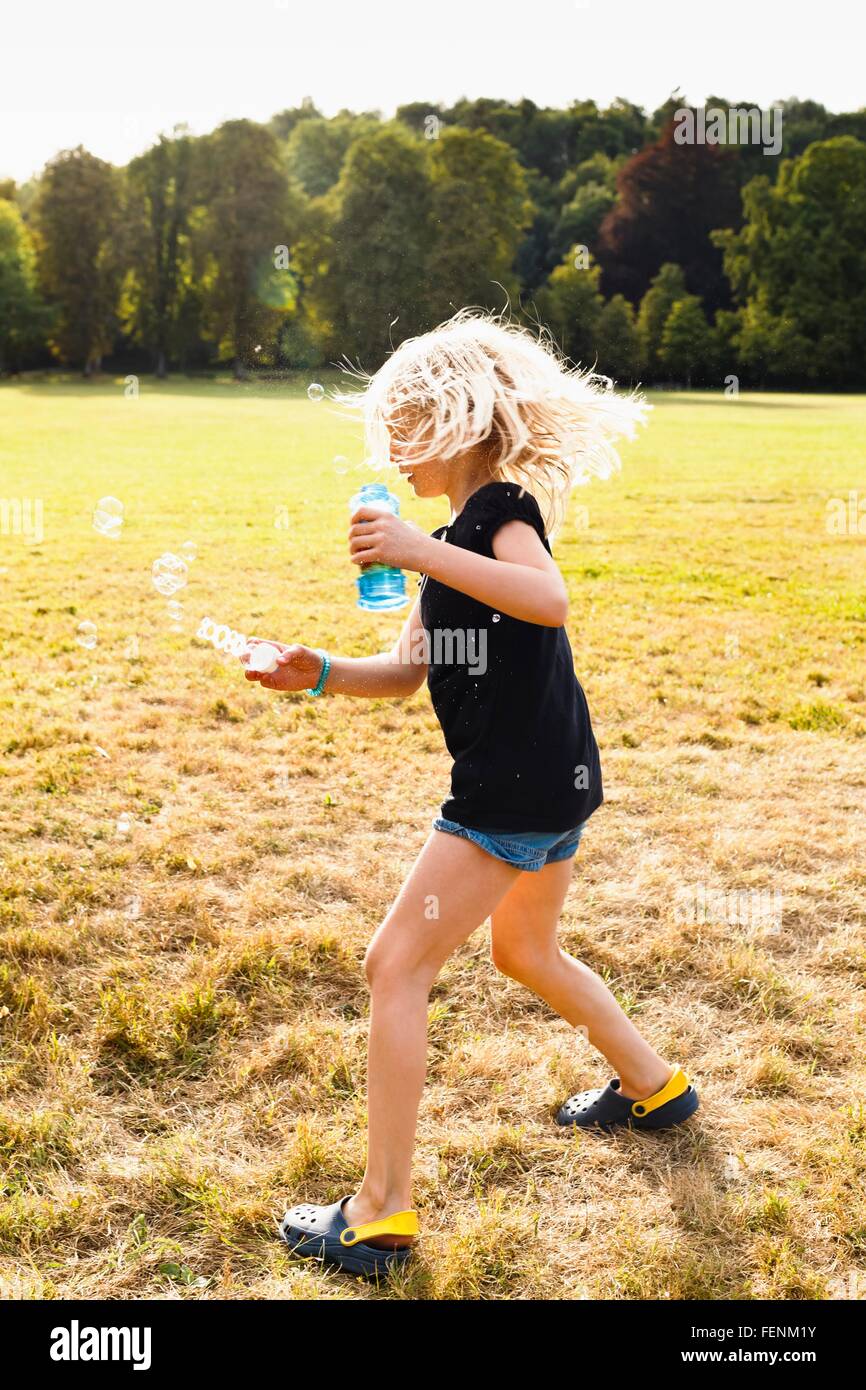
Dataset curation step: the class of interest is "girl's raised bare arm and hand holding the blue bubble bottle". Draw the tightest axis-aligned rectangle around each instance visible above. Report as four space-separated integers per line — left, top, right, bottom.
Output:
349 507 569 627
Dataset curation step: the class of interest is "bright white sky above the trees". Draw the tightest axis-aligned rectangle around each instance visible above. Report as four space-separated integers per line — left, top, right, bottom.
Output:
0 0 866 181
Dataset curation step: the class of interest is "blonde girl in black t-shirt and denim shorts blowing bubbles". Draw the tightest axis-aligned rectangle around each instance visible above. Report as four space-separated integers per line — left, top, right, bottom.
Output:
243 310 698 1275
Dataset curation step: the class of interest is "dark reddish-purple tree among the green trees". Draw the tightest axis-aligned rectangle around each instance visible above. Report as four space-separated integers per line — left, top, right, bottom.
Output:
594 121 741 310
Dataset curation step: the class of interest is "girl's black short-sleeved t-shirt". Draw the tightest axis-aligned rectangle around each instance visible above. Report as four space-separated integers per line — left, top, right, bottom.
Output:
421 482 603 831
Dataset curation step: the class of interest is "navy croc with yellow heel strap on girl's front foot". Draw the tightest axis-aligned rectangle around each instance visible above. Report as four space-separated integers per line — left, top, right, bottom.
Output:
279 1197 418 1279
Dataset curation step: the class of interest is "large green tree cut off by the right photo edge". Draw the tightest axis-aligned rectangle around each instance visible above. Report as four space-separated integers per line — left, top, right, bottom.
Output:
714 135 866 384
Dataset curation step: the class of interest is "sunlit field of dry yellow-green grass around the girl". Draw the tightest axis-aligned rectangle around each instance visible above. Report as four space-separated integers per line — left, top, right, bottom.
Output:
0 379 866 1300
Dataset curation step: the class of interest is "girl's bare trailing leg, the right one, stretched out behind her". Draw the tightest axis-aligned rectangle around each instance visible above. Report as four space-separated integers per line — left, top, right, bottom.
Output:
492 859 673 1099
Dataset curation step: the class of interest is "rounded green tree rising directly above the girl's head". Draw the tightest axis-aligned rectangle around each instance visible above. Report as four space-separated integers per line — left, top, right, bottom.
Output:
427 126 532 320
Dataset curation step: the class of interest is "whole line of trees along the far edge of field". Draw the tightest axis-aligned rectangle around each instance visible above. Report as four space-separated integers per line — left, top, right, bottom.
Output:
0 95 866 388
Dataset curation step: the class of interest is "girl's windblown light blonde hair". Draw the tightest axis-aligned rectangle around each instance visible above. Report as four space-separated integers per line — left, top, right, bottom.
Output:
334 309 651 534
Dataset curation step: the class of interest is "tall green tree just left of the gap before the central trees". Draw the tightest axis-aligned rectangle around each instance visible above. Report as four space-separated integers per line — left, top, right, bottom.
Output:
195 121 303 377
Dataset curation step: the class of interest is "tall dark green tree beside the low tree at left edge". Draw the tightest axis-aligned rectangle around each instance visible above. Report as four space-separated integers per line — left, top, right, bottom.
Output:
33 146 122 377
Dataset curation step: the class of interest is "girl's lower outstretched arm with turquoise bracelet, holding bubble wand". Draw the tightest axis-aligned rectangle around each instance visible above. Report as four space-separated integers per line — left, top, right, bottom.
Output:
240 599 427 699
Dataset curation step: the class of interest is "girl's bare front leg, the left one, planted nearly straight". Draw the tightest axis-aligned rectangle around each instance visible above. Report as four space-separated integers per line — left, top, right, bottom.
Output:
343 830 521 1244
